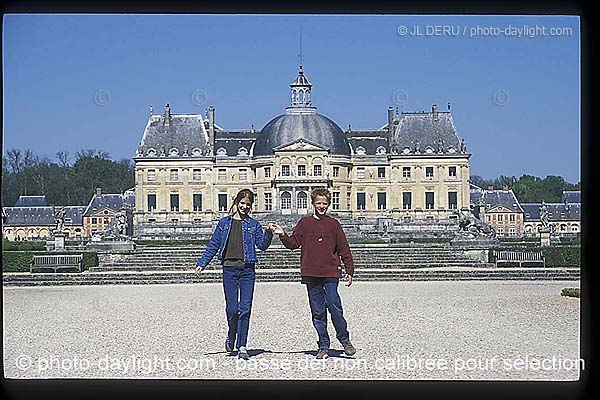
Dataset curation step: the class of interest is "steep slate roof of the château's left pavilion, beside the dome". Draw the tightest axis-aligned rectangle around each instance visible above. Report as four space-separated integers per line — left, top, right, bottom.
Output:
136 105 208 158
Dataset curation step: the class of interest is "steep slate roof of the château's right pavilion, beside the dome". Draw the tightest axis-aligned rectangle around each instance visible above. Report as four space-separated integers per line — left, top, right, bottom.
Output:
393 111 467 156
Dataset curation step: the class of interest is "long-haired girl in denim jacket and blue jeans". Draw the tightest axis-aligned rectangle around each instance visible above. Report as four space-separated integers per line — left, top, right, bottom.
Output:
196 189 273 360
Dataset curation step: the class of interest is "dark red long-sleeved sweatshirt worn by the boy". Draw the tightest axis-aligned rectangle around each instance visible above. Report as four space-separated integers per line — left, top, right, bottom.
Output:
279 215 354 278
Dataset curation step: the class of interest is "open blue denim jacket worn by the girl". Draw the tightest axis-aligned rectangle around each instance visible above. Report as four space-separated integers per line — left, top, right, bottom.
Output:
196 215 273 269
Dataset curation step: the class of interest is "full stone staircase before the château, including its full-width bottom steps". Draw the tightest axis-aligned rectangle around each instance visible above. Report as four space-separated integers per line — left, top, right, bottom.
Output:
2 244 580 286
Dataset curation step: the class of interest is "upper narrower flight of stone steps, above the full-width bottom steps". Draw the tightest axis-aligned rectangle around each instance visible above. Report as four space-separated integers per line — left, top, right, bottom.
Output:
90 245 491 273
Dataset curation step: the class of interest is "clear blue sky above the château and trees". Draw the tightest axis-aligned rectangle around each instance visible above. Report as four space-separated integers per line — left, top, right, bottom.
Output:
2 14 580 183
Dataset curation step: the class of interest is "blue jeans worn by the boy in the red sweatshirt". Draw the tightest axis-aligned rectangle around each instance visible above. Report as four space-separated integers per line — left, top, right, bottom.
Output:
306 281 350 350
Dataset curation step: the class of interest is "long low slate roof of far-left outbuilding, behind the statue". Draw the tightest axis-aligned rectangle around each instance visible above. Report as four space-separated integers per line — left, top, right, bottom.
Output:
3 206 85 226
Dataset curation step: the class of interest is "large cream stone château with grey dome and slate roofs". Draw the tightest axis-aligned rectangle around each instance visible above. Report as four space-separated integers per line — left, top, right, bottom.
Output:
134 65 470 236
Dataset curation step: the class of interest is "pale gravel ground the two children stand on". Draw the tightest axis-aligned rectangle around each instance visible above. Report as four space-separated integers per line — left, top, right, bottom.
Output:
3 281 581 380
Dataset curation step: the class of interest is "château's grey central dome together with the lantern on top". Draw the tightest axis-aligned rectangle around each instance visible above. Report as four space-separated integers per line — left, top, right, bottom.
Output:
254 65 350 156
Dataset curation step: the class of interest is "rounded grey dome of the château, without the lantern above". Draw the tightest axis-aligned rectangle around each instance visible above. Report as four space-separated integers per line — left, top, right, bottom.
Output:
254 111 350 156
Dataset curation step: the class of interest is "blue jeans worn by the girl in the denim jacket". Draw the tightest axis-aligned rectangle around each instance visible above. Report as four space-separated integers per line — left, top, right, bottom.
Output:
223 264 255 349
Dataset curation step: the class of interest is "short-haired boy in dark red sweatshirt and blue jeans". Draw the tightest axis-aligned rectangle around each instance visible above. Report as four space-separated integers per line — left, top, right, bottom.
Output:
273 188 356 359
